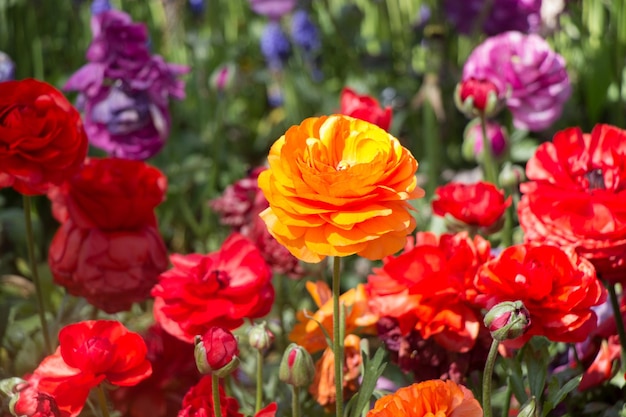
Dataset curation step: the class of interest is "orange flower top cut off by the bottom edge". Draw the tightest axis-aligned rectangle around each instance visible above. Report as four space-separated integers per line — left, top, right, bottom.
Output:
367 380 483 417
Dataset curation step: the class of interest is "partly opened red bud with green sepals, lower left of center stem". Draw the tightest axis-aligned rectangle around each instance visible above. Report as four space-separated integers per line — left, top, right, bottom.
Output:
194 327 239 378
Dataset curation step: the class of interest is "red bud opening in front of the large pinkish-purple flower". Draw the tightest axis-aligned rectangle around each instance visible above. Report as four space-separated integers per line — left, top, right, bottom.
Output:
454 78 504 117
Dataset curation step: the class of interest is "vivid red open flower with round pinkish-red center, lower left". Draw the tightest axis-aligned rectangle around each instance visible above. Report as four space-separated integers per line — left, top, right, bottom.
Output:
59 320 152 387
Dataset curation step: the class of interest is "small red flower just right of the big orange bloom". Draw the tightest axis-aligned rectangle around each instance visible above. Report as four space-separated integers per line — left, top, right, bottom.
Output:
432 181 511 229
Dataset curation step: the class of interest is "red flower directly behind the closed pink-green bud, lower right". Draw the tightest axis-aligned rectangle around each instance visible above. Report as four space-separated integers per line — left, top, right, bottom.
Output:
475 244 606 345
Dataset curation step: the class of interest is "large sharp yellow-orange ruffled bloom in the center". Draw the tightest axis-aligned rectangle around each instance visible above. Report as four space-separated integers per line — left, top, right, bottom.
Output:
259 115 424 262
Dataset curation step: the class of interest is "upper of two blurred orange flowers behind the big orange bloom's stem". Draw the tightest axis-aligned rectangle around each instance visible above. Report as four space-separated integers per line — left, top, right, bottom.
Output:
289 281 378 353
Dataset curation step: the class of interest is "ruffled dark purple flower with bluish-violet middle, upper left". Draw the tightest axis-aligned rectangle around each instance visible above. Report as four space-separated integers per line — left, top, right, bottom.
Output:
64 10 188 160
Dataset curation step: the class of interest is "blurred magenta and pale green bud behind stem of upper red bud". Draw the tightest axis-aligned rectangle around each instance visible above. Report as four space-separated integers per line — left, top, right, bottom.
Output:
462 118 508 162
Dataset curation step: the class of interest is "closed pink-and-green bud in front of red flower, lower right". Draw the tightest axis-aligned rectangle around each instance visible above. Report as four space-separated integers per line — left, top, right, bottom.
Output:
484 301 530 342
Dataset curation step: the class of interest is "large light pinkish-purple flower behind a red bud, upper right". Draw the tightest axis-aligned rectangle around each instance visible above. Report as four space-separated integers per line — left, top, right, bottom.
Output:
463 32 571 130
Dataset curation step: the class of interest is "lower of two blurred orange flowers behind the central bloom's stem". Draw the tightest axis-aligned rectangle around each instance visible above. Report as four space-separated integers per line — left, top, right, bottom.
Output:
309 334 363 407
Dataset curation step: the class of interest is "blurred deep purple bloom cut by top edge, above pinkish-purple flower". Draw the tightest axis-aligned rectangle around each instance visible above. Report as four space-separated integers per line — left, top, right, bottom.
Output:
444 0 541 36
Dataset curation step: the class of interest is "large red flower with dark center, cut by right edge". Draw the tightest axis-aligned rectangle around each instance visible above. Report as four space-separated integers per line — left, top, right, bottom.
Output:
518 125 626 283
